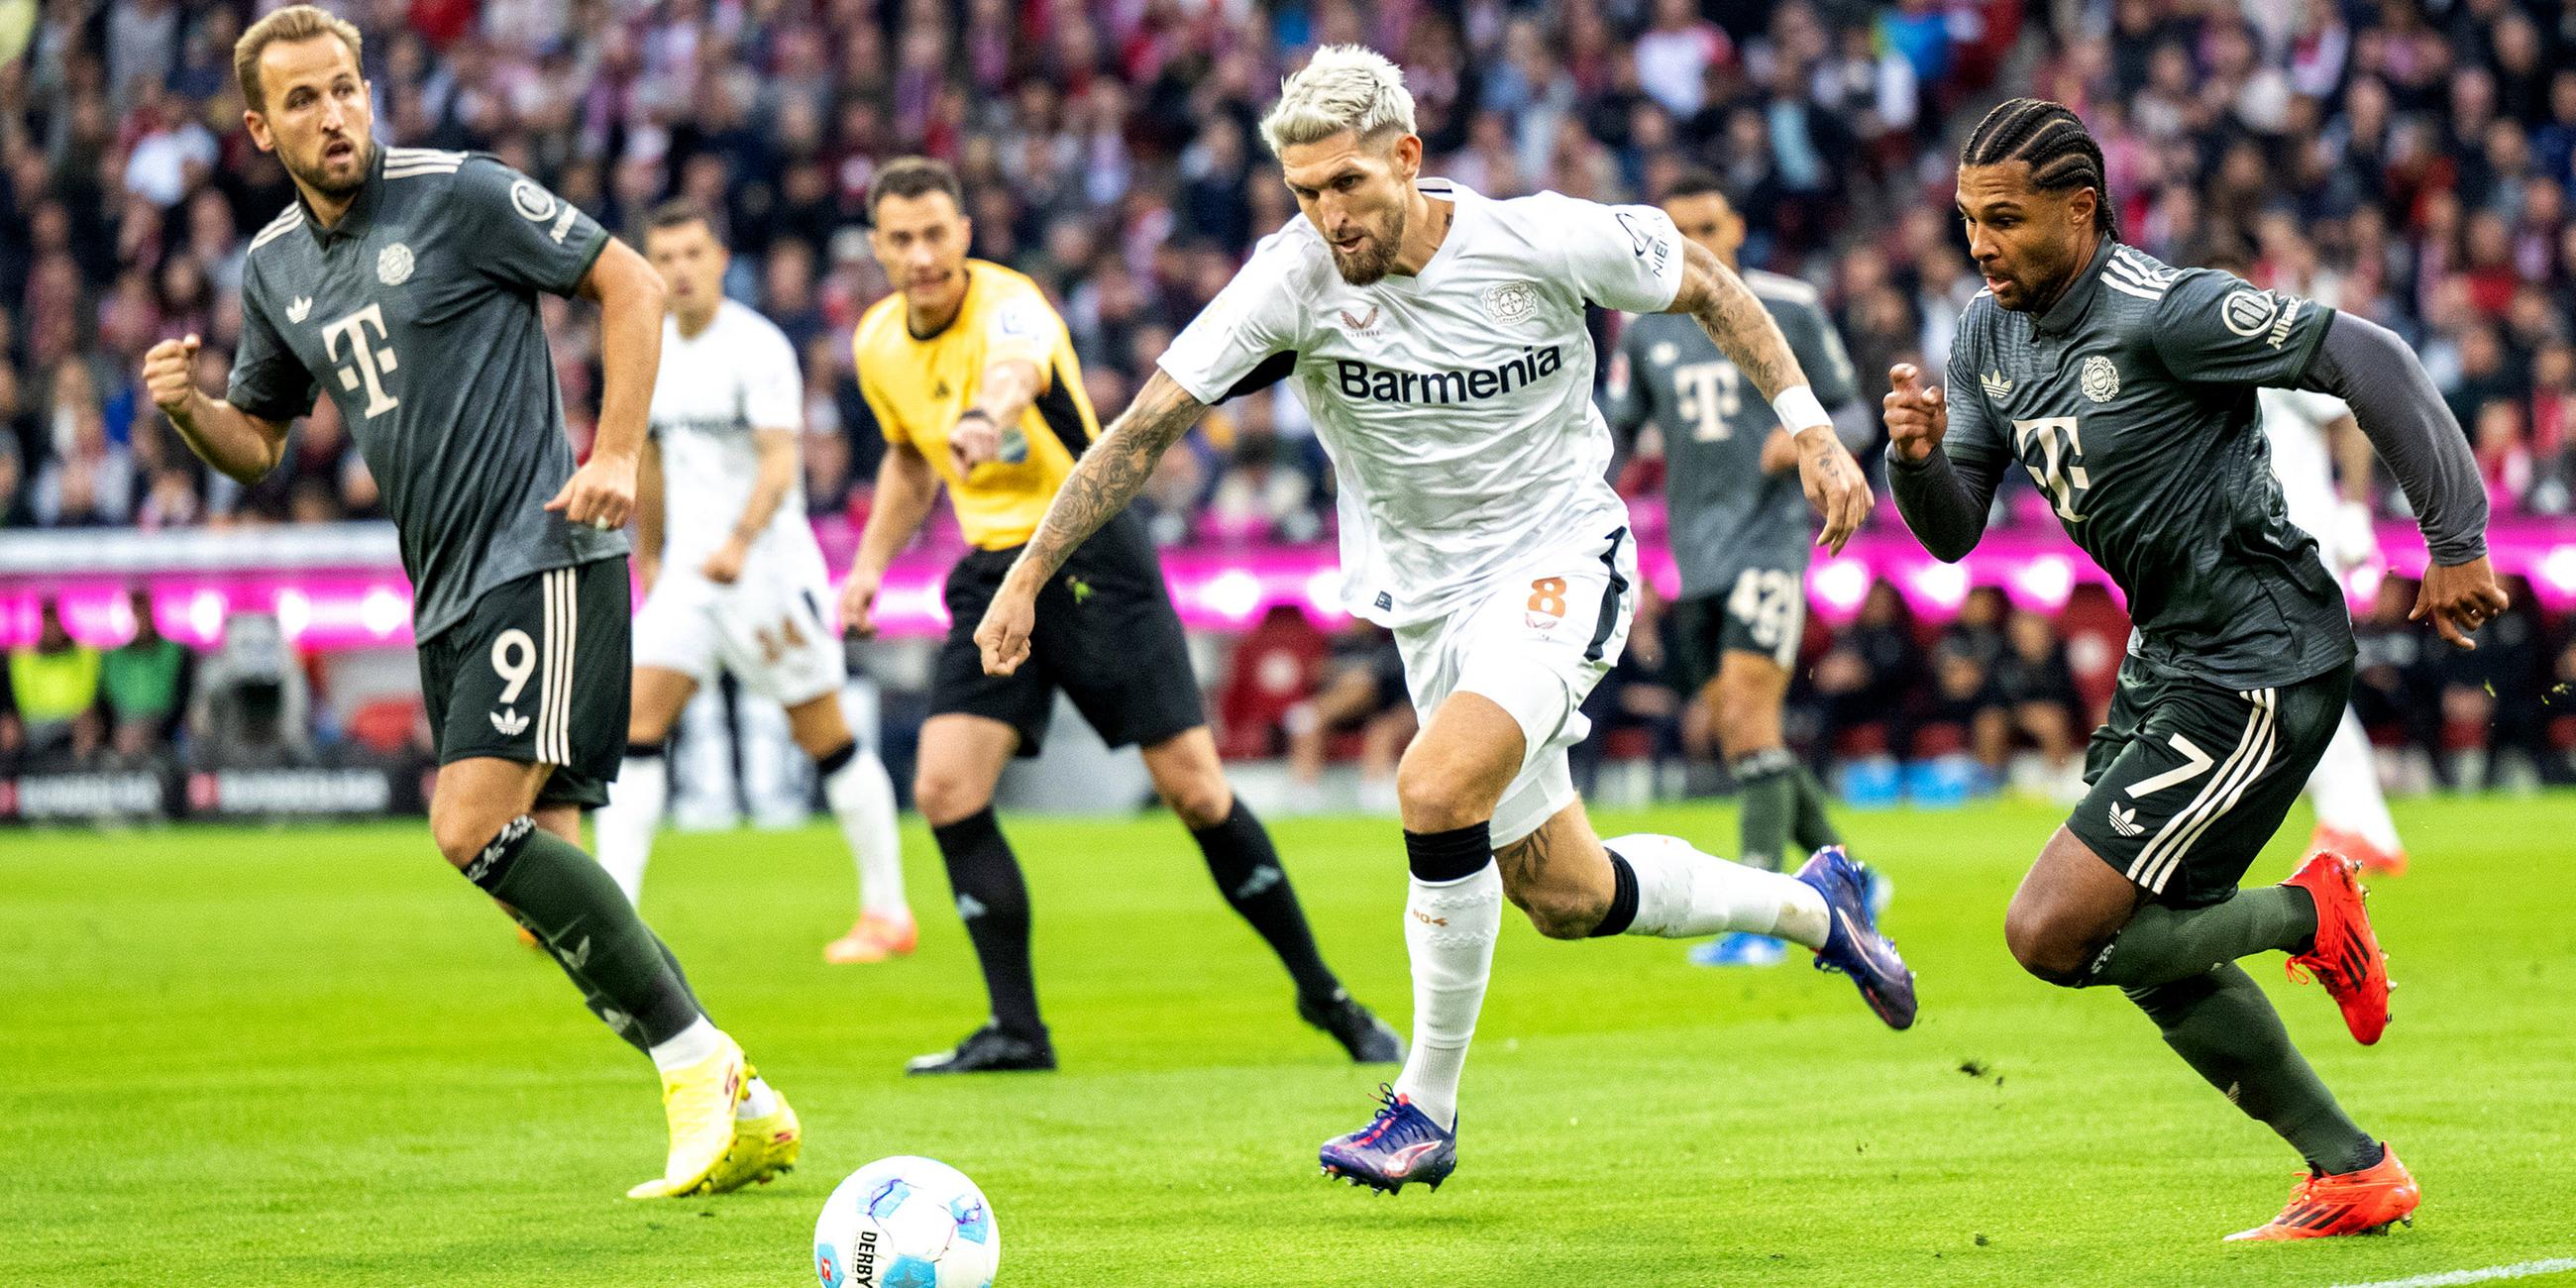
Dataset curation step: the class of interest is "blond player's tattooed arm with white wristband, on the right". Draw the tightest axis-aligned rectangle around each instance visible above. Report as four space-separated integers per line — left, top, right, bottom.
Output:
1664 240 1876 554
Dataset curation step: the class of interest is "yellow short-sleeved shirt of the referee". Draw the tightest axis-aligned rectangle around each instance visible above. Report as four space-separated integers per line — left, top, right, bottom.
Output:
850 261 1100 551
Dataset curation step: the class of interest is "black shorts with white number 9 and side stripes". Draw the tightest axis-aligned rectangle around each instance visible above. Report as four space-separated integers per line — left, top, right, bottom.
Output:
420 557 634 808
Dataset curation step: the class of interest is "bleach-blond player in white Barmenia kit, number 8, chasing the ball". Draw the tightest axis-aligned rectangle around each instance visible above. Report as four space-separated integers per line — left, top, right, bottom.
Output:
976 44 1914 1190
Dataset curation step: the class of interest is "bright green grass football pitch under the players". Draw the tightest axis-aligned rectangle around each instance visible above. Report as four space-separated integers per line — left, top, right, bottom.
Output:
0 796 2576 1288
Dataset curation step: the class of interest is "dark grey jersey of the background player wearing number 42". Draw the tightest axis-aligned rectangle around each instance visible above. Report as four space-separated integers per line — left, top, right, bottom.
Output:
1610 270 1860 597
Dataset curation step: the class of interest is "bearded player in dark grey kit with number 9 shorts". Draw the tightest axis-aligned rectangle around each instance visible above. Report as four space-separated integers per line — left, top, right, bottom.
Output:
142 5 799 1198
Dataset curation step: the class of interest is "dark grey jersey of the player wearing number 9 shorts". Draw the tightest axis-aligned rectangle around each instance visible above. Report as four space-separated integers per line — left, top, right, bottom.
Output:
227 147 626 639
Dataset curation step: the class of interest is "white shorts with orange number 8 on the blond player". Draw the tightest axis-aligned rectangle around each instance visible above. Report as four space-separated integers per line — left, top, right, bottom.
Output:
1396 525 1636 850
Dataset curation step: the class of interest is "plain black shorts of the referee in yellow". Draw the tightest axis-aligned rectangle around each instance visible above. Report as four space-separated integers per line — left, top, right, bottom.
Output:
930 515 1208 755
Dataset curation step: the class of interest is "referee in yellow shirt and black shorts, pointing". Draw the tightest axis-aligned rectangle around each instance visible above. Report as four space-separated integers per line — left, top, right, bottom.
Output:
840 158 1404 1074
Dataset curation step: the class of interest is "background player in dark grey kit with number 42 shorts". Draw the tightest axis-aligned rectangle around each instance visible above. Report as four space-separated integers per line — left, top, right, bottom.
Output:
1610 170 1865 966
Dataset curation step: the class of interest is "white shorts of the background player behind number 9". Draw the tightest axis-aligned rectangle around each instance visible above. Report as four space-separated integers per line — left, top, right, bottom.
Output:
634 567 850 708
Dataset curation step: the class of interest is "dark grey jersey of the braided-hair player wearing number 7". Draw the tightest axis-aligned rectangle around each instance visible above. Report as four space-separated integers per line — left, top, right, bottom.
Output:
1942 242 2352 688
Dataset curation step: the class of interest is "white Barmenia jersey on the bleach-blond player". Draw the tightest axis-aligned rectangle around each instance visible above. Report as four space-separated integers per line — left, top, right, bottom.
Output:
1162 180 1682 626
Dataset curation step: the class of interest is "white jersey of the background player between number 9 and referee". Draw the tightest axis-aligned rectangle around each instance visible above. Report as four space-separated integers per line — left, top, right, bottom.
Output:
649 299 821 577
